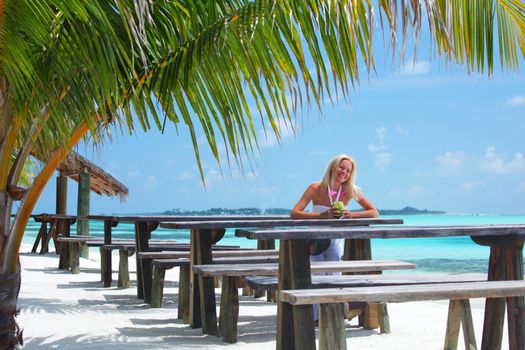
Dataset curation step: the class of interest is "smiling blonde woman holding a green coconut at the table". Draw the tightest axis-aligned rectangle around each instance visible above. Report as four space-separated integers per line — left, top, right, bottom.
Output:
290 154 379 322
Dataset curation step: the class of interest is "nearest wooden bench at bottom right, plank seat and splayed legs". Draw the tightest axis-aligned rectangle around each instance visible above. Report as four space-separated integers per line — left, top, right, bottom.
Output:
279 280 525 349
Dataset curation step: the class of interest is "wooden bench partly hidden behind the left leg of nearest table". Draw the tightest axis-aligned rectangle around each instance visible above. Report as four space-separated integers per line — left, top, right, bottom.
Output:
193 260 416 343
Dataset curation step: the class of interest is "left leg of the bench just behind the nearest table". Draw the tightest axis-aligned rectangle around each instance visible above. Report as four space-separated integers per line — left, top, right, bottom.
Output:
219 276 239 343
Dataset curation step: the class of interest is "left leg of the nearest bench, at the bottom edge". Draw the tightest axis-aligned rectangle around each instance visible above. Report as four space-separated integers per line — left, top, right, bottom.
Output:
319 303 346 350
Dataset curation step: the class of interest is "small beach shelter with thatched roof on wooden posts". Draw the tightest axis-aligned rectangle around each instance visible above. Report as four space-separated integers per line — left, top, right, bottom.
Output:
56 151 128 257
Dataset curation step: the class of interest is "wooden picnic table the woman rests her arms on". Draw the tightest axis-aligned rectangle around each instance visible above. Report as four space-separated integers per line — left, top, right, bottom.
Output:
160 217 403 335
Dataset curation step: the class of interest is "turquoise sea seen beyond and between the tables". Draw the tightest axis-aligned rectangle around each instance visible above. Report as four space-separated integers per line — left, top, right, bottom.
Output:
23 215 525 272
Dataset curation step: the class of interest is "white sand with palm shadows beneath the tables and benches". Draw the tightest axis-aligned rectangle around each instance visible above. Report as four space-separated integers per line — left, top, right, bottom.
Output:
18 246 508 350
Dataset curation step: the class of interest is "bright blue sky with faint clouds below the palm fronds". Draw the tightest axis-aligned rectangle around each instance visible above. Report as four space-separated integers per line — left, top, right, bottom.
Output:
31 31 525 214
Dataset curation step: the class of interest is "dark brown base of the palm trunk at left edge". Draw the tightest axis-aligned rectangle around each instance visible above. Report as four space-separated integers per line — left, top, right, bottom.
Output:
0 263 23 350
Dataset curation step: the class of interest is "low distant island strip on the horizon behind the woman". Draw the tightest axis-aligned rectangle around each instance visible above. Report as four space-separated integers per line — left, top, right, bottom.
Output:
131 207 445 215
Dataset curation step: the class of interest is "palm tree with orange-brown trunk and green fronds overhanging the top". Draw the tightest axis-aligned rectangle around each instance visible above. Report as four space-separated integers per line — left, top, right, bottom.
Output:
0 0 525 348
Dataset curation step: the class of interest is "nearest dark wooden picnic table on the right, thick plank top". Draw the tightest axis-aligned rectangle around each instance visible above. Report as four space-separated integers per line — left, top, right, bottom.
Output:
236 225 525 350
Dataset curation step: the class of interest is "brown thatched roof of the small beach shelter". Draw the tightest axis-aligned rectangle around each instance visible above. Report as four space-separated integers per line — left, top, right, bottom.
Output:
58 150 128 200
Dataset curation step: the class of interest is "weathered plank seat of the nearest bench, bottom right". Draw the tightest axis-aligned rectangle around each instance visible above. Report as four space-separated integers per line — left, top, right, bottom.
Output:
279 281 525 305
